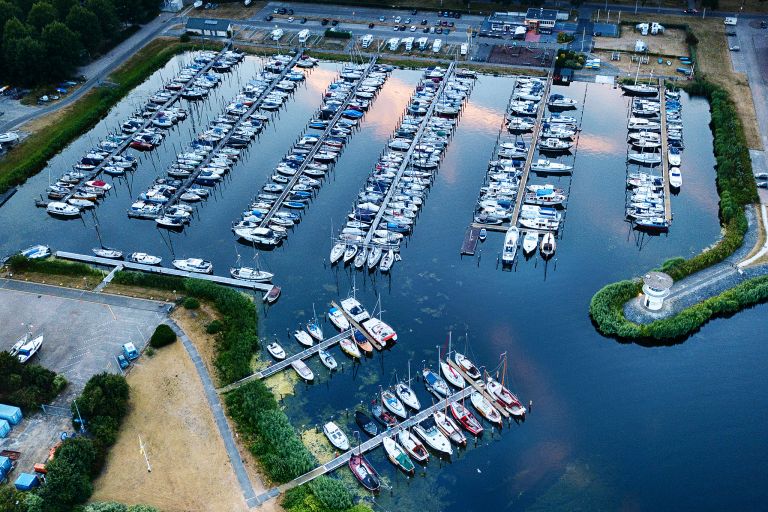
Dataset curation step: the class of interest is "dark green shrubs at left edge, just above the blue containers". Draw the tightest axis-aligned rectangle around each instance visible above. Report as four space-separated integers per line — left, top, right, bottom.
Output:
0 352 67 412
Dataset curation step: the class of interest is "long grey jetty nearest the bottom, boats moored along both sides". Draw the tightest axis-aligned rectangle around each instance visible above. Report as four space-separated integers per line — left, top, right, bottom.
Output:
256 386 475 503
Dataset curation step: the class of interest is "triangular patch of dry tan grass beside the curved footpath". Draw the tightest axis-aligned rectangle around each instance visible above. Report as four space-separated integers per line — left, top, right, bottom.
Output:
93 343 247 512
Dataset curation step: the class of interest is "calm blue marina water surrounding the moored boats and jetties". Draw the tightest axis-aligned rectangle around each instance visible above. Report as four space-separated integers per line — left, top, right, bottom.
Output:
0 58 768 511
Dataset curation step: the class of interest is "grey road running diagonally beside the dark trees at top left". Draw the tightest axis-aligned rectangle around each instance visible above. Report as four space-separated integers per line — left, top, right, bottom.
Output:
0 12 177 132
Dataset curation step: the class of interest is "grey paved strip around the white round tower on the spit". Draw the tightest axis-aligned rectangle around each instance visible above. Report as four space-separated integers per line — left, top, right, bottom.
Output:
624 208 768 324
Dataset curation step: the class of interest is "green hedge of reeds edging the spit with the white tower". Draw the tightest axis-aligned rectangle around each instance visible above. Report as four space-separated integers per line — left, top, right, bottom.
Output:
589 80 768 341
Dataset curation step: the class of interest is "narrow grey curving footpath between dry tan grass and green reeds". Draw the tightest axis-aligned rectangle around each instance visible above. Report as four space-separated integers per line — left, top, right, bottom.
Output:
166 319 266 508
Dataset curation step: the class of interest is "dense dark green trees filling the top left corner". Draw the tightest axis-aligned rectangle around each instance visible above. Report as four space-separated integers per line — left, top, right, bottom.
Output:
0 0 160 86
